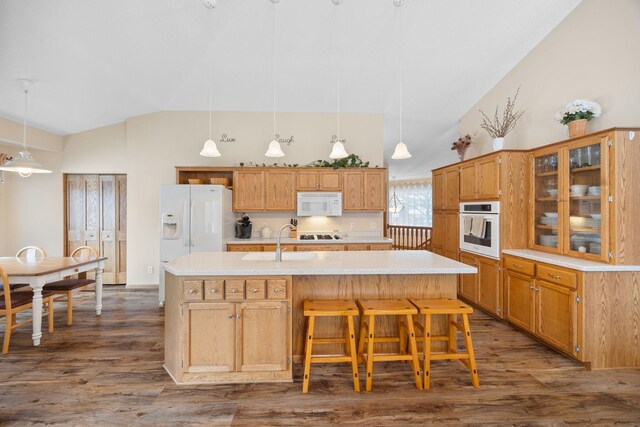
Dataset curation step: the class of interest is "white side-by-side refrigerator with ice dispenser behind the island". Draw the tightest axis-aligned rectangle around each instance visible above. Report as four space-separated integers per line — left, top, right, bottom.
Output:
158 185 235 305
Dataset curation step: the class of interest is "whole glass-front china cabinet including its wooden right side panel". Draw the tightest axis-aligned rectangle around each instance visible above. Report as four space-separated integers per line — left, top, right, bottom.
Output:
529 130 640 264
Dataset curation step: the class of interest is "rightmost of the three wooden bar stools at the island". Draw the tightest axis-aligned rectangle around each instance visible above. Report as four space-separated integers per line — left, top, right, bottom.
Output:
411 299 480 390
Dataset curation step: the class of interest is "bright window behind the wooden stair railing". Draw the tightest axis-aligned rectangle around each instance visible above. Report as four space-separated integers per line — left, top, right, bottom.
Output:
389 179 433 227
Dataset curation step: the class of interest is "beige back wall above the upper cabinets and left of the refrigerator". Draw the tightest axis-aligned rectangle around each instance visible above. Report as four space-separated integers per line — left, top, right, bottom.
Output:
126 112 383 285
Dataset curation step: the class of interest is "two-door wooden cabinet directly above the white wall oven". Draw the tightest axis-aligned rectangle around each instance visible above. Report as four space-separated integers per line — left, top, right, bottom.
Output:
460 155 500 200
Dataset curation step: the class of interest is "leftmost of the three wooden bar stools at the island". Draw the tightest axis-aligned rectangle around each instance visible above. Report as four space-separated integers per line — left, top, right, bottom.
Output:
302 300 360 393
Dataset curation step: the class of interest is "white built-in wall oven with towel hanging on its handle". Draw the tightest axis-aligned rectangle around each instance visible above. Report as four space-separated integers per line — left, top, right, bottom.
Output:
460 202 500 259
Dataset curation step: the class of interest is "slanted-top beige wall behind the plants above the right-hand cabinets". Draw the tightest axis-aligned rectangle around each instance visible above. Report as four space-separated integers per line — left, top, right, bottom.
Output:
460 0 640 158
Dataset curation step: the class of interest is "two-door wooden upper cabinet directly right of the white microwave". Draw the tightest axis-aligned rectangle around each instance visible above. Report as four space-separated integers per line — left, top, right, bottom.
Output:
342 169 387 211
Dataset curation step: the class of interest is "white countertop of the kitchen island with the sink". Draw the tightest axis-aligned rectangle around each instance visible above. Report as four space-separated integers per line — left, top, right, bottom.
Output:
164 251 478 276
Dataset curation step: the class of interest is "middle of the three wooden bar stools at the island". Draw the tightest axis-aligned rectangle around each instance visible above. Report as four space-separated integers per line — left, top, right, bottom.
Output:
358 299 422 391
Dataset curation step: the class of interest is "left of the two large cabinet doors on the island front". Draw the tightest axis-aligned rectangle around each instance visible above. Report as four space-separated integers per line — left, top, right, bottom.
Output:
182 303 236 373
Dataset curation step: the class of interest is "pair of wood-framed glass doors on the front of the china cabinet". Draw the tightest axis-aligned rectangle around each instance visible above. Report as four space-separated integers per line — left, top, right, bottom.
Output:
530 135 609 262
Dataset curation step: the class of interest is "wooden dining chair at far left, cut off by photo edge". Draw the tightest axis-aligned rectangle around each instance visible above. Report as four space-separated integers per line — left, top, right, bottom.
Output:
0 268 53 354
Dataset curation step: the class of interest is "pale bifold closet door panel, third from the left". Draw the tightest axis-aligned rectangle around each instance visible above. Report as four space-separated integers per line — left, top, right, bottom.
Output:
100 175 118 284
